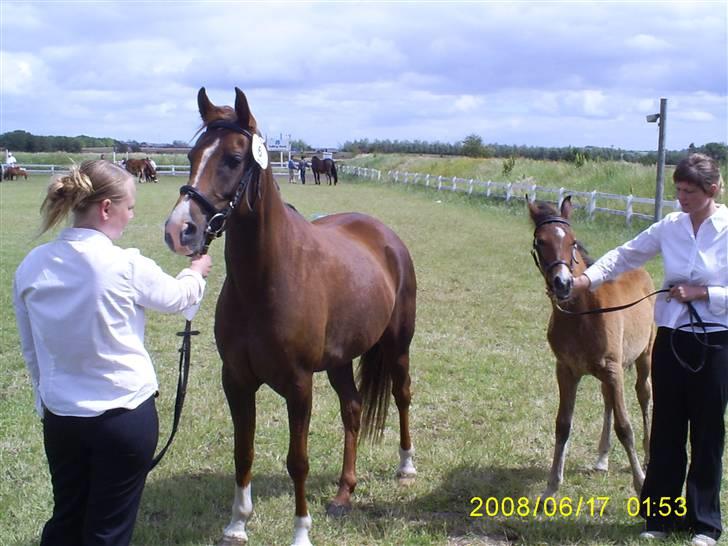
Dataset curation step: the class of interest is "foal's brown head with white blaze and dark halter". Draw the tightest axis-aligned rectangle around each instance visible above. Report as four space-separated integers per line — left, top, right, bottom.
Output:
528 196 579 300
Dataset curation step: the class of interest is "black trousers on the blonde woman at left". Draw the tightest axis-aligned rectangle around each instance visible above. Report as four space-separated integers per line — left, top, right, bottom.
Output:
41 397 159 546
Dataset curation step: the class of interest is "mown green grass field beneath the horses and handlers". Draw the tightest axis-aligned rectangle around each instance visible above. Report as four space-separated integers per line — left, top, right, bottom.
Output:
0 171 728 546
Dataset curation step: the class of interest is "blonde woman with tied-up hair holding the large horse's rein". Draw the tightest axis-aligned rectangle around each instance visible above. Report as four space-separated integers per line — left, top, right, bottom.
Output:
13 160 211 546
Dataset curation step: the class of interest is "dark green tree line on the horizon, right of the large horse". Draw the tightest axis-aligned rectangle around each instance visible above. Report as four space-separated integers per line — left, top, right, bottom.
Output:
341 134 728 165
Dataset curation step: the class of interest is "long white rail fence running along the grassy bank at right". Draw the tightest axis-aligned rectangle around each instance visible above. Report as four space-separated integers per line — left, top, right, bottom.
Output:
338 164 680 225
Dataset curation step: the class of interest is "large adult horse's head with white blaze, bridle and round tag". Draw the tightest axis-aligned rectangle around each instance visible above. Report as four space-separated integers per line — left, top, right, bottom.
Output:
164 87 267 256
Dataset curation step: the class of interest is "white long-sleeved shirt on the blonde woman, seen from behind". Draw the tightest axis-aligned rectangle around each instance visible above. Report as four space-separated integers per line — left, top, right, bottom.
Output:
13 228 205 417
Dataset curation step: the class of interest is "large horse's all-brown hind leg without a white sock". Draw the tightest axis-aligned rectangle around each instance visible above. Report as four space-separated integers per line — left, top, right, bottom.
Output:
326 362 361 516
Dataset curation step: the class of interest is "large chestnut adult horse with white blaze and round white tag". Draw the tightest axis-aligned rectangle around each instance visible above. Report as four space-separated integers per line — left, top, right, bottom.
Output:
165 87 416 546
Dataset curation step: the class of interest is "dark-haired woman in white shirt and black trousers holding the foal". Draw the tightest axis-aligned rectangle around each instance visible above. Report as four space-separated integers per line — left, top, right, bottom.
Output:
574 154 728 546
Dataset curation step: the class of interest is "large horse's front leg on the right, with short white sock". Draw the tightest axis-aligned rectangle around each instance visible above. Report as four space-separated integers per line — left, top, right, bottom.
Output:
286 372 313 546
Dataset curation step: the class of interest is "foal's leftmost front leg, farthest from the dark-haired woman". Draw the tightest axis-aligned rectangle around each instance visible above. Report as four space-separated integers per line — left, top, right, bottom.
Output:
542 361 580 498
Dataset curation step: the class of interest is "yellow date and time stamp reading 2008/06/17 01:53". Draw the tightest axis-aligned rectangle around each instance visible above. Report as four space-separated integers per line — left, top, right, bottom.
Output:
470 496 687 518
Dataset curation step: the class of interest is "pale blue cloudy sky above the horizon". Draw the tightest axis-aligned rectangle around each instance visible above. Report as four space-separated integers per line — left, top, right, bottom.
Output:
0 0 728 150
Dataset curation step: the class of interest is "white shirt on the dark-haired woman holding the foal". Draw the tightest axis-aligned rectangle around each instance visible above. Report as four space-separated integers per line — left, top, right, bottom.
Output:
584 205 728 330
